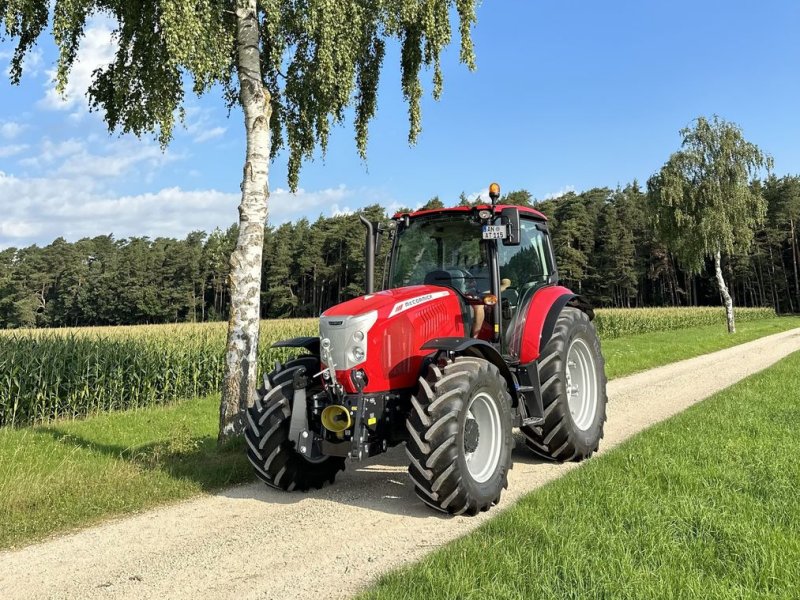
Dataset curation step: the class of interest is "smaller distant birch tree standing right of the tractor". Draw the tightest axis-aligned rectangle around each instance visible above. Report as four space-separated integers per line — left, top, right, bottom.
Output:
647 115 772 333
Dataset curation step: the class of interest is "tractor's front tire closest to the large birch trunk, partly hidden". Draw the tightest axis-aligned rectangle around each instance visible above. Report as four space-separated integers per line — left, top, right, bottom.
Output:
245 356 345 492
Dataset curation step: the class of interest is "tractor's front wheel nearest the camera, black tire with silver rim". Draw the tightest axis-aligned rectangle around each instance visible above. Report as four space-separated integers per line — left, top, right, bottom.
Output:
406 357 514 515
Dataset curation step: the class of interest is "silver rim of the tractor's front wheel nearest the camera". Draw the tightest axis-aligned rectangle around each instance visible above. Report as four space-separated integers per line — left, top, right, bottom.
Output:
464 392 502 483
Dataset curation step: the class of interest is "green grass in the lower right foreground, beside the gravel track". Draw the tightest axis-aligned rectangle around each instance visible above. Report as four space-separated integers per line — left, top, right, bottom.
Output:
360 353 800 600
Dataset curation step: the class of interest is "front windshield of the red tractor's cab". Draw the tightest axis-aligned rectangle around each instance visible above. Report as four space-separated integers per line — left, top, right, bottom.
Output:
389 213 491 295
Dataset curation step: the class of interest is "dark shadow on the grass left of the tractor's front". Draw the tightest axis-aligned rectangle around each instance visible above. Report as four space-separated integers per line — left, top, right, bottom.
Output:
37 427 252 492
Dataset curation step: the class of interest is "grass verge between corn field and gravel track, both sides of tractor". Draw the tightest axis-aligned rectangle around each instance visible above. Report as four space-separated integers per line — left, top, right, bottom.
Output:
0 318 800 548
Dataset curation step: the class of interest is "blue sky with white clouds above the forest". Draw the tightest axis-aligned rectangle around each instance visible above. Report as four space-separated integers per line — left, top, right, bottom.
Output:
0 0 800 249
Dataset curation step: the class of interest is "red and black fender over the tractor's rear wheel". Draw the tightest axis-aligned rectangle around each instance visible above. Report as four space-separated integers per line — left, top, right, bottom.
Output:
520 285 594 364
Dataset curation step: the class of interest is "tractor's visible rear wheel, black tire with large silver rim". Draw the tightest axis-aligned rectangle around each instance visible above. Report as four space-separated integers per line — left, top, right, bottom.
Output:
521 307 607 462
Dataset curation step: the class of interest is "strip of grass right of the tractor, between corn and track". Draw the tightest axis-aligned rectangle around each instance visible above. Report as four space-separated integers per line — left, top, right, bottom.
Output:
602 317 800 379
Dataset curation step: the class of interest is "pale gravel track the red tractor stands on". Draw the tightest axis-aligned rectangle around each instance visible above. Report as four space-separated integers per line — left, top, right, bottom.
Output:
0 329 800 600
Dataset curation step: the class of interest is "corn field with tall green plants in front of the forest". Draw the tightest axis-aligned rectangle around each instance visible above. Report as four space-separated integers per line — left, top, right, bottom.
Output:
0 308 775 426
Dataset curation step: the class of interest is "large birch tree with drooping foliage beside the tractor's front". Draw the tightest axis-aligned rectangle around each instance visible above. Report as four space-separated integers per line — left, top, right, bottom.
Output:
0 0 478 441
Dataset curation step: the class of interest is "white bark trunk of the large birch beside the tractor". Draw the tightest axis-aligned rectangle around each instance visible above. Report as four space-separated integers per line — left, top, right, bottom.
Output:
219 0 271 443
